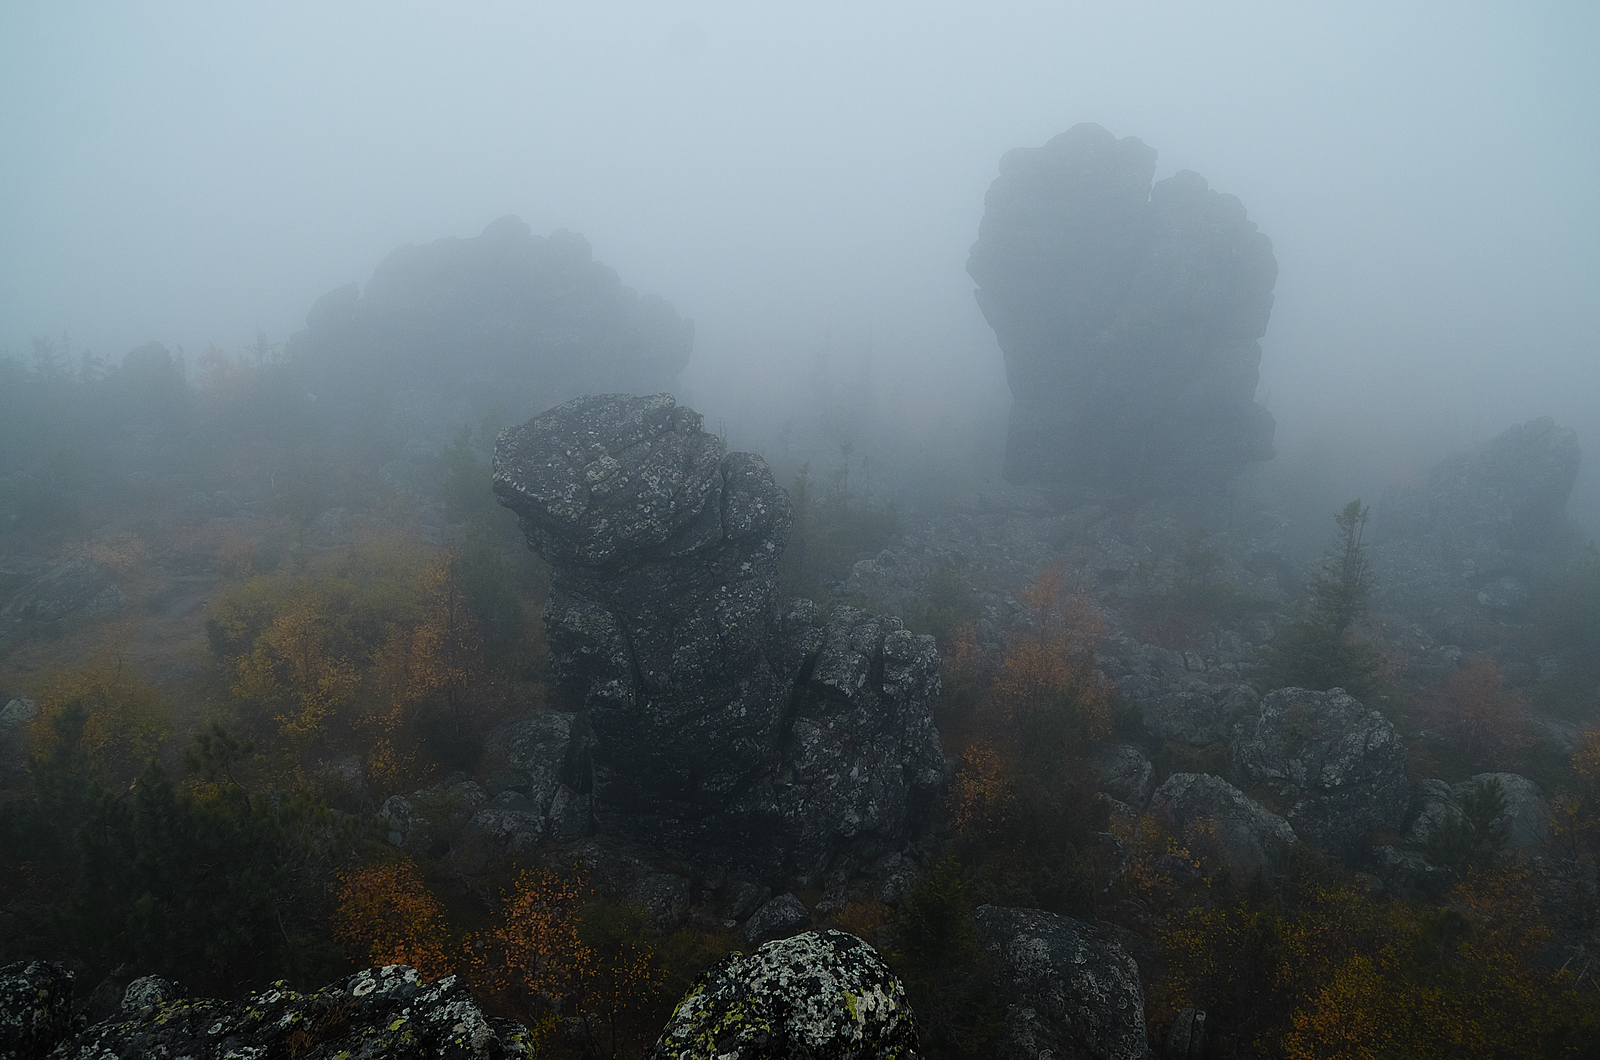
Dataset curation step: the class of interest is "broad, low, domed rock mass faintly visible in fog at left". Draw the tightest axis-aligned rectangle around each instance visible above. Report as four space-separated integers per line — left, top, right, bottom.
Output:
290 216 694 416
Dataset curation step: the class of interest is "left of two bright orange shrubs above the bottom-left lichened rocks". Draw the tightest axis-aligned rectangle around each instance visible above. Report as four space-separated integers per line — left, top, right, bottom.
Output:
333 860 456 980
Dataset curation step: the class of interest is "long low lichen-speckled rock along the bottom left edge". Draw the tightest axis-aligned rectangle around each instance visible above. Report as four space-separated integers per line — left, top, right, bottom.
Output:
54 964 533 1060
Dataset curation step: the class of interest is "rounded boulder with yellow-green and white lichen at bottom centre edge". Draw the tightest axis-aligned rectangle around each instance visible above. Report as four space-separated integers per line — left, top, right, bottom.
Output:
636 930 917 1060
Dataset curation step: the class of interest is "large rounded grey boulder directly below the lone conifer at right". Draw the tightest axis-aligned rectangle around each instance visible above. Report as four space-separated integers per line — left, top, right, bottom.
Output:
1234 689 1410 853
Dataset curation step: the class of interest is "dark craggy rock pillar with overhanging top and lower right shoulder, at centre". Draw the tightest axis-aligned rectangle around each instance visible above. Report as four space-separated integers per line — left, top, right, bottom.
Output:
494 394 944 874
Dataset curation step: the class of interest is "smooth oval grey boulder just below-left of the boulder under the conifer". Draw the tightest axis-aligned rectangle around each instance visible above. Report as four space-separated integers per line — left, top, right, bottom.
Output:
1150 773 1294 876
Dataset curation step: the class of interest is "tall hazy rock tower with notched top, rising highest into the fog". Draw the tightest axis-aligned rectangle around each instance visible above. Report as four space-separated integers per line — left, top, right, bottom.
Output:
966 123 1278 493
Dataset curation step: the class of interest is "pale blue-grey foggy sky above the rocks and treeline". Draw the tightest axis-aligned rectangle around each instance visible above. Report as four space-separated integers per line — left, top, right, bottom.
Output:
0 2 1600 530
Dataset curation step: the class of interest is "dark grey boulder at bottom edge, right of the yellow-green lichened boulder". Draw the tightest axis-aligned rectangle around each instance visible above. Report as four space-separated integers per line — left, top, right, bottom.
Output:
971 905 1147 1060
